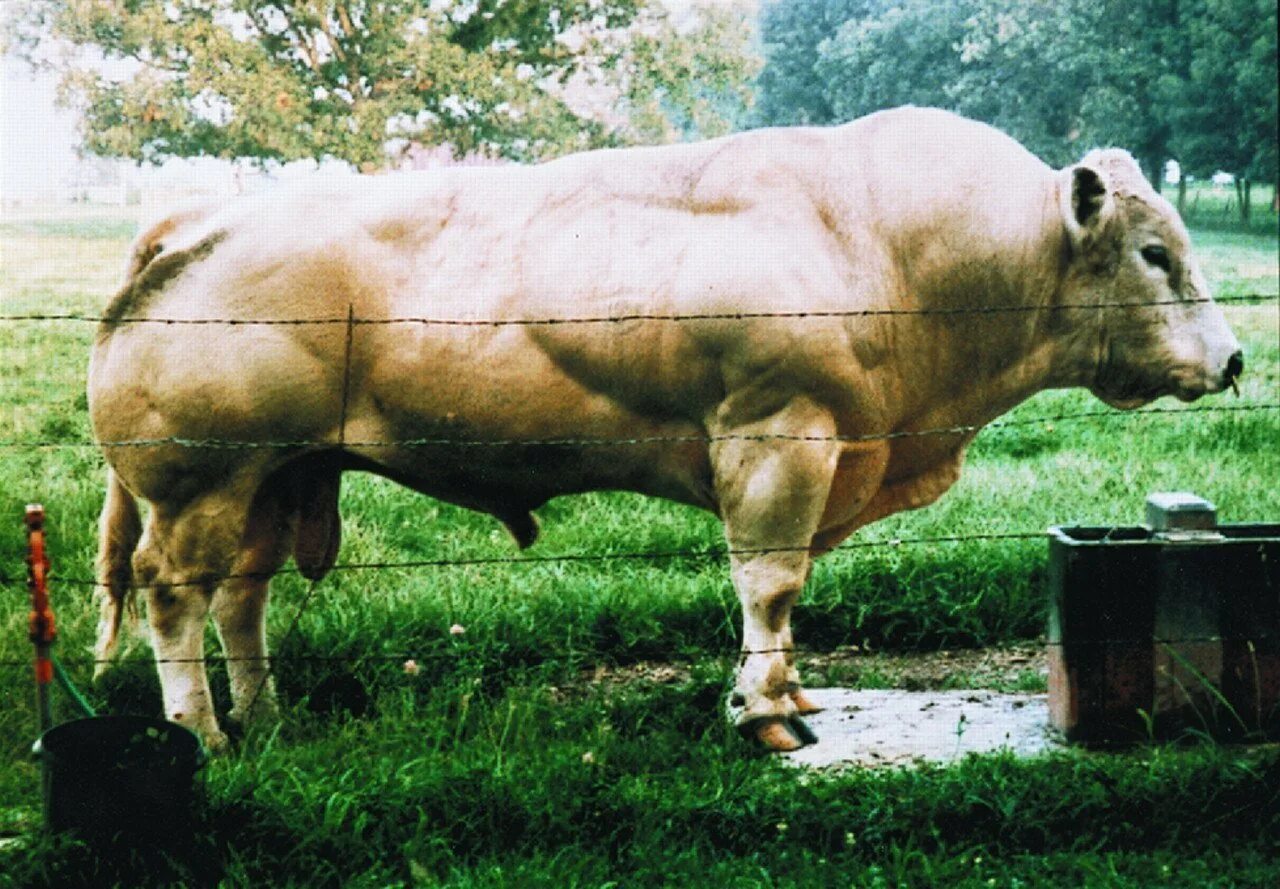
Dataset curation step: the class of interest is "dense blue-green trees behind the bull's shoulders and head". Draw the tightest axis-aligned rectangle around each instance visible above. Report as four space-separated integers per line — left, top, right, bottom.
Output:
756 0 1277 209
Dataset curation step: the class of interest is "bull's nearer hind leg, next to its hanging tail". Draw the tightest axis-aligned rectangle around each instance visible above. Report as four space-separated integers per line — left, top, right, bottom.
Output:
133 486 257 750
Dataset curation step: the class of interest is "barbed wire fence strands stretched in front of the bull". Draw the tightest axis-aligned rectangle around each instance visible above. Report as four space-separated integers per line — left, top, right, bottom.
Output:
0 294 1280 736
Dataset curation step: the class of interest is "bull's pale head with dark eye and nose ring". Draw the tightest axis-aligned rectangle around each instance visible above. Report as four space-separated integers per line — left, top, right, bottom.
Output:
1059 148 1244 408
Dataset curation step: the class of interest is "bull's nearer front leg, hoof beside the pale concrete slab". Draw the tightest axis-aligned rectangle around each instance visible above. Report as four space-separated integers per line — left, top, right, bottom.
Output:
712 400 840 751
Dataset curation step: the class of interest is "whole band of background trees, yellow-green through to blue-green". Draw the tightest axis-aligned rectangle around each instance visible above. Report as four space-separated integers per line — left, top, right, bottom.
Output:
5 0 1280 223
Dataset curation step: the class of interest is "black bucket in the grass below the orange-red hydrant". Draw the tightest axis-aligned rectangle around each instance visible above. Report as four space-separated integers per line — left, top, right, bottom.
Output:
33 716 205 848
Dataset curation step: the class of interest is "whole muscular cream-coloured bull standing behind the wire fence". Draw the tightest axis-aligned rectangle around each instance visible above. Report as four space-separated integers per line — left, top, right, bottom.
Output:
88 109 1243 750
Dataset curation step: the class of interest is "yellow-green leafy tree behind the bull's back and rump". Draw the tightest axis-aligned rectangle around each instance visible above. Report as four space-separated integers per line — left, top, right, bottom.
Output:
9 0 754 169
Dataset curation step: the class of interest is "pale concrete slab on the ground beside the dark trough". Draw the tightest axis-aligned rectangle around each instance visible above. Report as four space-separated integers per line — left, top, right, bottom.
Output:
785 688 1065 769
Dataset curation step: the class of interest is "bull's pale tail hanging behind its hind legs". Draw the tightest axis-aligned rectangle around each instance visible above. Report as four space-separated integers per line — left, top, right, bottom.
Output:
93 469 142 678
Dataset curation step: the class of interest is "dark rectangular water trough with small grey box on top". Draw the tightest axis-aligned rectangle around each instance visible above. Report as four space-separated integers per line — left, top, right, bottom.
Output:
1048 494 1280 744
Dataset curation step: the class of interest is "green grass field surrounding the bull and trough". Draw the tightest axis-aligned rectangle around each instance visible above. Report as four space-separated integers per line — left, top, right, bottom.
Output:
0 204 1280 886
